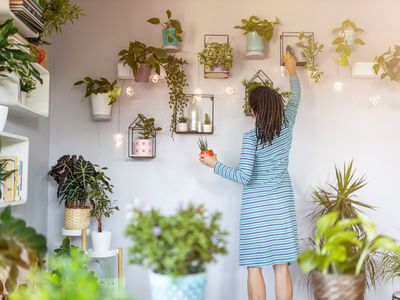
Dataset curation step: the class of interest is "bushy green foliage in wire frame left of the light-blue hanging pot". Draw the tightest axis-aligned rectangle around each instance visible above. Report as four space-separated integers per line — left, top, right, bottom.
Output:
198 43 233 69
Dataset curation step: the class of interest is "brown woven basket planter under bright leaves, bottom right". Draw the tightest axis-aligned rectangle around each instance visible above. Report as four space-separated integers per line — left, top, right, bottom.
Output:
311 271 365 300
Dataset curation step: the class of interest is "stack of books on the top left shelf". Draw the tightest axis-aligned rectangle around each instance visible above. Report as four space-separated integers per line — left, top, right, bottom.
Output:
10 0 43 32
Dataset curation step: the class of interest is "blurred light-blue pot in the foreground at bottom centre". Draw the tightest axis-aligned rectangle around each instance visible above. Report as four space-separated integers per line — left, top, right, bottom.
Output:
149 271 207 300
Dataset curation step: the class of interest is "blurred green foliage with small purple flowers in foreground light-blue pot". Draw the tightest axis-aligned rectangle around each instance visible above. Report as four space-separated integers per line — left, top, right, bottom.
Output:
126 204 227 276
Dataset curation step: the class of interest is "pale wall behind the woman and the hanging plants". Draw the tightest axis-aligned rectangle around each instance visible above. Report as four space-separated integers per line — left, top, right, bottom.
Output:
48 0 400 300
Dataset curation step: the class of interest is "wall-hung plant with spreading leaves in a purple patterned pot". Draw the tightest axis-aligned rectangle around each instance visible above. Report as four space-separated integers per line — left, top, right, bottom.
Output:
118 41 167 82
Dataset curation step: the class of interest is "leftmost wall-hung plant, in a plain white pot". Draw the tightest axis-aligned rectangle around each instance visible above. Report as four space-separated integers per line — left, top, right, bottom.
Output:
74 77 122 120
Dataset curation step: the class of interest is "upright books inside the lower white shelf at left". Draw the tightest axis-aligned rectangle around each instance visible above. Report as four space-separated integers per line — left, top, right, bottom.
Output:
0 156 24 202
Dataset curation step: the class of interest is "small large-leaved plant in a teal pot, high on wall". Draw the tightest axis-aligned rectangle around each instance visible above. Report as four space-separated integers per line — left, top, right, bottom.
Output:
147 10 183 51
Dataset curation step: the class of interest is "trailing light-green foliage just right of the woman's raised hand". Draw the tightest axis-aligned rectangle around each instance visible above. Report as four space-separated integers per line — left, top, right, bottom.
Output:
296 32 324 82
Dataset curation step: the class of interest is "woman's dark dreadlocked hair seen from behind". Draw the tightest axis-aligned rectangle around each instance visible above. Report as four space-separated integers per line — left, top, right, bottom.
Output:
249 86 285 145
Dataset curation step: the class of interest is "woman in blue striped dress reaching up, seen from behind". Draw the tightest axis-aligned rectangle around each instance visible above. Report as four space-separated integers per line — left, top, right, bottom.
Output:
200 54 300 300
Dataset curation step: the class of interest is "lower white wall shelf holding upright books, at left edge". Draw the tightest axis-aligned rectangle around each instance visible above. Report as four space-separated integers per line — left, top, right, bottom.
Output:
0 132 29 207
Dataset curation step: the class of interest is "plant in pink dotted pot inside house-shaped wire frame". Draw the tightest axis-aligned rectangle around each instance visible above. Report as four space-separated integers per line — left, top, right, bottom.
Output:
133 114 162 157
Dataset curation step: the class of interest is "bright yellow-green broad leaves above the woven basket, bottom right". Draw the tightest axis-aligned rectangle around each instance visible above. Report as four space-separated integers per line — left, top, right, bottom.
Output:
298 211 398 275
